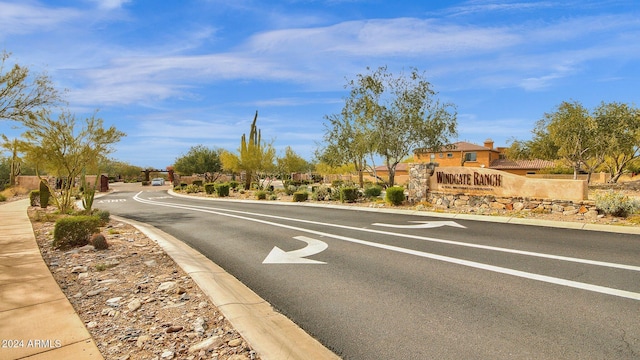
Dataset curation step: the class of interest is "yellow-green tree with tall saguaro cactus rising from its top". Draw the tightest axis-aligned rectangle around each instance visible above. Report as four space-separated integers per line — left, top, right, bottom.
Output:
220 111 276 190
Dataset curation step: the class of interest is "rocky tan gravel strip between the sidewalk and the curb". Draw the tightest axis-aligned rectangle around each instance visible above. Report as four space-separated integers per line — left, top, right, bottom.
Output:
29 208 260 360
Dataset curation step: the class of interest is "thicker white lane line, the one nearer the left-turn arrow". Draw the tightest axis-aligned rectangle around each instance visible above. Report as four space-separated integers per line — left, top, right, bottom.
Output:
134 193 640 300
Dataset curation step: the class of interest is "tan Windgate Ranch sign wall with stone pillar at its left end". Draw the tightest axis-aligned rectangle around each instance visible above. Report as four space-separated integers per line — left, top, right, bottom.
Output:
409 163 588 202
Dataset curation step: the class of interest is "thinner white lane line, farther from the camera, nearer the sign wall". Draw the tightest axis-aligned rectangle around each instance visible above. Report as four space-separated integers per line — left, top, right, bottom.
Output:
131 193 640 272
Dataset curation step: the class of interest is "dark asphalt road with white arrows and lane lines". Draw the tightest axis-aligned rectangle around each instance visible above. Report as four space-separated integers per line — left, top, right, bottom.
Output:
96 184 640 359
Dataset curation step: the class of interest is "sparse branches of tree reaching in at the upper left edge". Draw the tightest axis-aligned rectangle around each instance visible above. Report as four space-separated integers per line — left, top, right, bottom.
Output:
0 51 61 121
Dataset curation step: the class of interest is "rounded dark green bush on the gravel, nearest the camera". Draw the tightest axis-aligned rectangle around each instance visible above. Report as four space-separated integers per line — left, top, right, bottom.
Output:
53 215 100 250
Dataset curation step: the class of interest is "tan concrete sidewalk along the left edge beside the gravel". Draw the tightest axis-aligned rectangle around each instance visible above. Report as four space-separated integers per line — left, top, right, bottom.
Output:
0 199 103 359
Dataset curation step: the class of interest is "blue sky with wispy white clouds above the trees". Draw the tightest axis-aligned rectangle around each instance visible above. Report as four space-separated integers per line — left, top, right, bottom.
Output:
0 0 640 168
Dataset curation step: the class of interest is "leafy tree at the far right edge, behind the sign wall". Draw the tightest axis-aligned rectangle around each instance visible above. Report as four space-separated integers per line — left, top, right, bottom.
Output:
593 102 640 183
